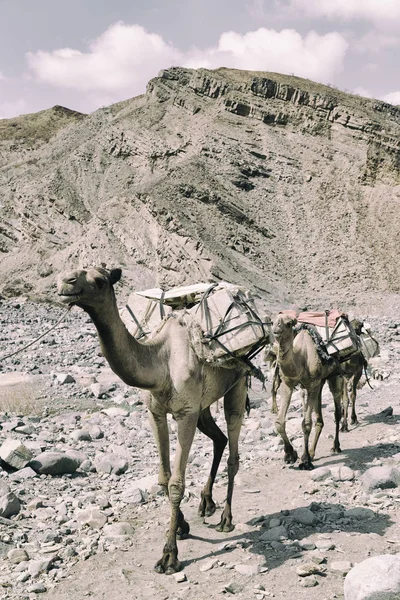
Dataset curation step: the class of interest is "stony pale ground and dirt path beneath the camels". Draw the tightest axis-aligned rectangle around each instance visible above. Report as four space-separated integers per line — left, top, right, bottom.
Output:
0 299 400 600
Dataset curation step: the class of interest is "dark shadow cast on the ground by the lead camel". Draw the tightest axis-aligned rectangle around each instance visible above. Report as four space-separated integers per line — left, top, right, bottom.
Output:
182 502 393 571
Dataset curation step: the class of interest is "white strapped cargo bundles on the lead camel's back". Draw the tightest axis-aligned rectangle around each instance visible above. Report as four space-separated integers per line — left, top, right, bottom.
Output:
121 281 271 376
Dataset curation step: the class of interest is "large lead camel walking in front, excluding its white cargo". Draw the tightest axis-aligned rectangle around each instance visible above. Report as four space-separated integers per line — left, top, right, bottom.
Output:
58 268 247 575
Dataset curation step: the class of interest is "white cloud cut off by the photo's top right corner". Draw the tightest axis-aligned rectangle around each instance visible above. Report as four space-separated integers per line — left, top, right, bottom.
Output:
290 0 400 24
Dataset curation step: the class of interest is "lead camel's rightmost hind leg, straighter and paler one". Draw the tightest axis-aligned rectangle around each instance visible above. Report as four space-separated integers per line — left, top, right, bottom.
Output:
217 378 247 532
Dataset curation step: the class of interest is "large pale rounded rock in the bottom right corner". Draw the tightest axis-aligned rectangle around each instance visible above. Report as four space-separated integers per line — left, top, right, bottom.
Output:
344 554 400 600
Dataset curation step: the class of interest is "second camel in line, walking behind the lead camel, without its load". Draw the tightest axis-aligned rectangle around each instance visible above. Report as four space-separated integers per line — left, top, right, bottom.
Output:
272 314 343 469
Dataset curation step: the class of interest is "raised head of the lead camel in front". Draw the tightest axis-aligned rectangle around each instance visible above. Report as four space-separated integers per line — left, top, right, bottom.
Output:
57 267 121 309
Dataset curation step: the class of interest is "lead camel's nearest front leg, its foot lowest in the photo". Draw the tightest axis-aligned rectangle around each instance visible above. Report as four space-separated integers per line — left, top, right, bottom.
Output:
154 413 199 575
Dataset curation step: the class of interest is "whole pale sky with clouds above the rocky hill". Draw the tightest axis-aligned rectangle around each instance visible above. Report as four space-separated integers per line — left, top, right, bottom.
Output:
0 0 400 119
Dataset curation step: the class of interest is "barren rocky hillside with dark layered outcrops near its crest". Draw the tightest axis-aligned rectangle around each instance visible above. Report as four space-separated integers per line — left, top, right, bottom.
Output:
0 68 400 308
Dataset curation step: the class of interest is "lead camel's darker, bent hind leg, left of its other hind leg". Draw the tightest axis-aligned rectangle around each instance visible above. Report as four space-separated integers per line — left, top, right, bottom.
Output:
197 408 228 517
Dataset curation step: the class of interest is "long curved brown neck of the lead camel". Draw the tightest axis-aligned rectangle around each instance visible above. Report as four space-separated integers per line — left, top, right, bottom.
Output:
86 298 160 390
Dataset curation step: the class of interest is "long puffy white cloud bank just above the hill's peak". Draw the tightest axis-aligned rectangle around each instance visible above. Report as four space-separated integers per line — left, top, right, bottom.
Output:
27 22 348 110
